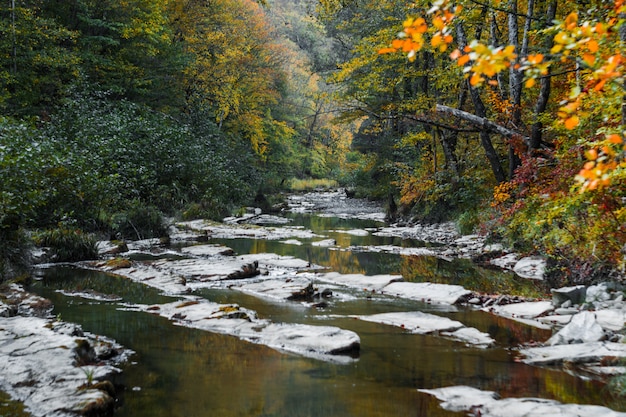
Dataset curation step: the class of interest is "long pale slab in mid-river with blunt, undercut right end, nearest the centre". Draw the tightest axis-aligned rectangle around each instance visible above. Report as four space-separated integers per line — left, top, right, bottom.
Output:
137 298 361 363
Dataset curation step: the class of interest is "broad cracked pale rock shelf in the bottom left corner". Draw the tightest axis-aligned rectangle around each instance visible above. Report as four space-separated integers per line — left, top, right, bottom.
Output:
0 316 130 417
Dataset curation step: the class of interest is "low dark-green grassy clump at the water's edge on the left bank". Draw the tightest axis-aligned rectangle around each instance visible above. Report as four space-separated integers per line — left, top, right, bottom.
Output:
35 225 98 262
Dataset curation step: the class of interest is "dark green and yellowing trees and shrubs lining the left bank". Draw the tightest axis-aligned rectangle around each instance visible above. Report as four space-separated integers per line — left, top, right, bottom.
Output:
0 0 346 274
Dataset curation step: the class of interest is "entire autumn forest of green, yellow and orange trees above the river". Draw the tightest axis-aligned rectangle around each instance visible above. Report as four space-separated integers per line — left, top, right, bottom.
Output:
0 0 626 284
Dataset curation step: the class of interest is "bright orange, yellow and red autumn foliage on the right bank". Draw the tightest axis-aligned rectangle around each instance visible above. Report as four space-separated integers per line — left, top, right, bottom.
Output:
378 0 626 279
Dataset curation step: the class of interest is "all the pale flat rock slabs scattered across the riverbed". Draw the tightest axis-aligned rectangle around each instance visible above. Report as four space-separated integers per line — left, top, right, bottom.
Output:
0 191 626 417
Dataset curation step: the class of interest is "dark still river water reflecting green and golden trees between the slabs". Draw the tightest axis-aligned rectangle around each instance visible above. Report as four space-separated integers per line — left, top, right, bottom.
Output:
25 211 615 417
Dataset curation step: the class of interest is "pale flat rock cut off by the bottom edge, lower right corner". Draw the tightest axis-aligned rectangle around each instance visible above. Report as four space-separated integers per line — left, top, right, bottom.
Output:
419 386 626 417
